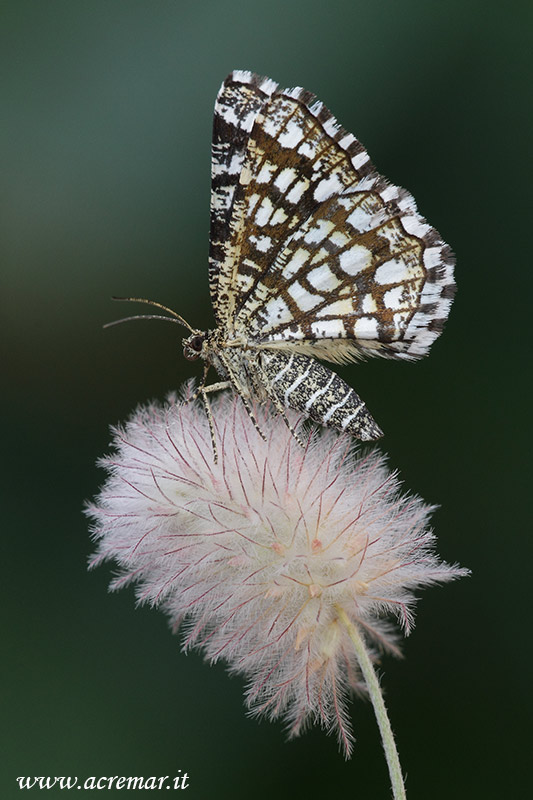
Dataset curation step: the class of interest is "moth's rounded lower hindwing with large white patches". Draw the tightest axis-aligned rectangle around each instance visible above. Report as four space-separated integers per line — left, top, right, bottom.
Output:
236 184 455 362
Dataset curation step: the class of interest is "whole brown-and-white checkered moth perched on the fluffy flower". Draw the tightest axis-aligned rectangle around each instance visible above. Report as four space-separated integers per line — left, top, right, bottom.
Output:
110 70 455 460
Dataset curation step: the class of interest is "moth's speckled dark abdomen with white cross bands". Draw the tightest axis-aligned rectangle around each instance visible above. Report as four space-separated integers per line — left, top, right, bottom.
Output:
261 351 383 441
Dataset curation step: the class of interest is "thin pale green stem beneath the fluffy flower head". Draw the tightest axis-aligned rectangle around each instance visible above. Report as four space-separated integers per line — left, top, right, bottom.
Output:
335 606 405 800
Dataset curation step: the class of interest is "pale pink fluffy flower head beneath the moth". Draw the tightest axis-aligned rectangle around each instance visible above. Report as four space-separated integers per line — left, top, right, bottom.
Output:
88 387 466 754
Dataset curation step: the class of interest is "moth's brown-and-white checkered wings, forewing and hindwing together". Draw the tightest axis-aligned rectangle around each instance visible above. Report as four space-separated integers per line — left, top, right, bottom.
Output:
211 72 454 362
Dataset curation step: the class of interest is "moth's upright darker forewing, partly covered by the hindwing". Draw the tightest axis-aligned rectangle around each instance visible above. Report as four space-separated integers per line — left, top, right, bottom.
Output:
211 71 376 325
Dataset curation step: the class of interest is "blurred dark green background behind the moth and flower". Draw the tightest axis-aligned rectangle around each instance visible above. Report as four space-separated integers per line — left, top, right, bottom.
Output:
0 0 533 800
